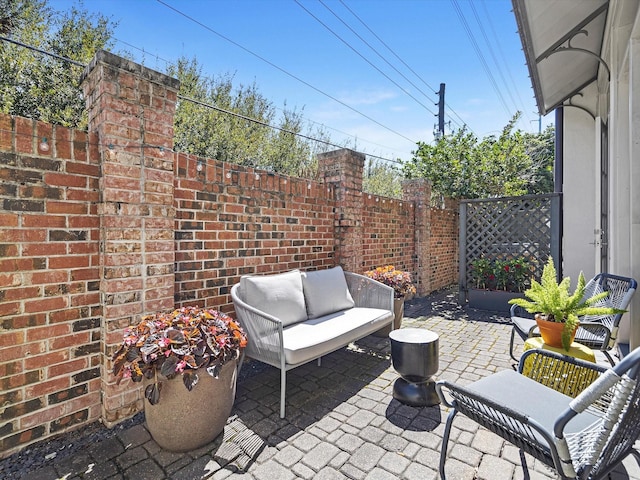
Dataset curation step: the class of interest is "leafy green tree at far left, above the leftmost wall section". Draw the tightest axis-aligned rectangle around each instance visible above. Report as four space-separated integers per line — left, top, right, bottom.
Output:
0 0 116 127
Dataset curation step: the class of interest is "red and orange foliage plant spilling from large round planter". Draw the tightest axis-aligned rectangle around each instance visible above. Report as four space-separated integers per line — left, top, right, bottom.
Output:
113 307 247 405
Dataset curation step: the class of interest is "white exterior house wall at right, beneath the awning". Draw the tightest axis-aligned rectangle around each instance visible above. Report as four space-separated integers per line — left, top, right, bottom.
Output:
562 0 640 349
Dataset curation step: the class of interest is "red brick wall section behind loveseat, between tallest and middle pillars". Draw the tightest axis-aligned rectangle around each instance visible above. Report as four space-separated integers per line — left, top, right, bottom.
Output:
175 154 335 312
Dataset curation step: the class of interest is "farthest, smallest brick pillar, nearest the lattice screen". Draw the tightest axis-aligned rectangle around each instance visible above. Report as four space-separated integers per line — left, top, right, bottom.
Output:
402 178 432 296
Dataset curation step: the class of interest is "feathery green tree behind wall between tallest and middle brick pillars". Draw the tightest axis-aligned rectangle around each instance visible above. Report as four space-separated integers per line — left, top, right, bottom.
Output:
168 57 330 177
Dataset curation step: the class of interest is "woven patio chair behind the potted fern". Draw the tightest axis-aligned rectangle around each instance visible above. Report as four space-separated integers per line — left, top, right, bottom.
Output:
509 273 638 365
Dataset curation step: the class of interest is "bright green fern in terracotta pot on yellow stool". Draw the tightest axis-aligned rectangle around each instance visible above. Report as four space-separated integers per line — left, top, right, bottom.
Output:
509 258 622 351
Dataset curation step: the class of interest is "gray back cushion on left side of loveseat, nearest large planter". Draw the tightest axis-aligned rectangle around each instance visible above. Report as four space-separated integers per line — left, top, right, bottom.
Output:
240 270 307 326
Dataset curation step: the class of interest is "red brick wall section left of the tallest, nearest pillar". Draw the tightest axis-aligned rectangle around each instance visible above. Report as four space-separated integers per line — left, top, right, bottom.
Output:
0 115 102 452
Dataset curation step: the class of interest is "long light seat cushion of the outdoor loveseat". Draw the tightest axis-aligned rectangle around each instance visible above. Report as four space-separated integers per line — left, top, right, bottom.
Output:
283 307 393 365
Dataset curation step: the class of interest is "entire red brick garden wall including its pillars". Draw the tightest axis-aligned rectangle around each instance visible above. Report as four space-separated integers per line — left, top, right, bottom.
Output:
0 52 458 457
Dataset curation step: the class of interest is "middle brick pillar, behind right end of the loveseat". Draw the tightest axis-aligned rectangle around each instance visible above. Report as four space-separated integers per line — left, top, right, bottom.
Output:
318 148 365 273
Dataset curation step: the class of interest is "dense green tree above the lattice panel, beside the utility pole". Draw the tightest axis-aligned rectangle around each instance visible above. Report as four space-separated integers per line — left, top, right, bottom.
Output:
403 113 553 198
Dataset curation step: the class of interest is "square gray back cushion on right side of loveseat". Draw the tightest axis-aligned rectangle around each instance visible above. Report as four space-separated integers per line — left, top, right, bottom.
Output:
302 266 355 318
